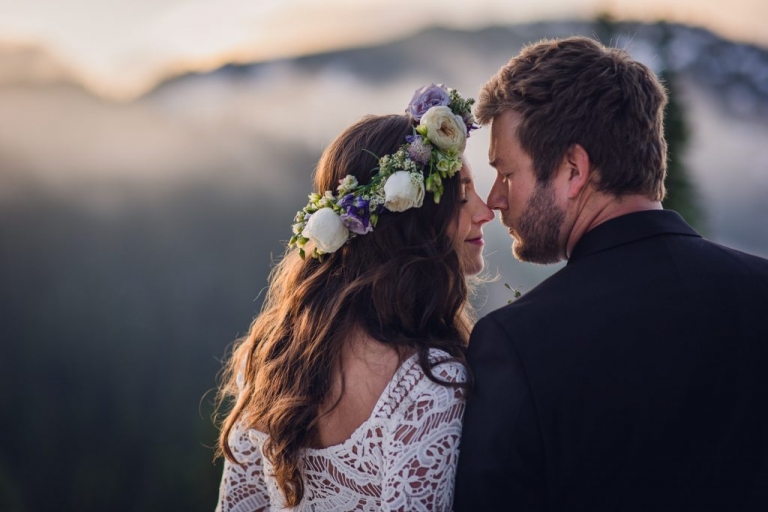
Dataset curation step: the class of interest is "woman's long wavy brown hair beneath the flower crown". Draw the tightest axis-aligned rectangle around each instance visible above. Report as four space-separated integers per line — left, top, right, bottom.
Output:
219 115 474 506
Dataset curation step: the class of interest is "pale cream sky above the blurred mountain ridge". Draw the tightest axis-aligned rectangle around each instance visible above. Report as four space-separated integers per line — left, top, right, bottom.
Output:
0 0 768 99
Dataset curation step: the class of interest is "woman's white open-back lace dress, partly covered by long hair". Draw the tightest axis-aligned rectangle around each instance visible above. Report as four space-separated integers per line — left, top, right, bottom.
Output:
216 349 466 512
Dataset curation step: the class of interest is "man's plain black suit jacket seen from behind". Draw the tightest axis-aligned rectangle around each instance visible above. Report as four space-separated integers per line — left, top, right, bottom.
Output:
454 210 768 511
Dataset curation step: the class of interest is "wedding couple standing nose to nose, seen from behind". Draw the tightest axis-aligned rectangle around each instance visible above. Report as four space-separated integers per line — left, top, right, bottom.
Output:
219 38 768 511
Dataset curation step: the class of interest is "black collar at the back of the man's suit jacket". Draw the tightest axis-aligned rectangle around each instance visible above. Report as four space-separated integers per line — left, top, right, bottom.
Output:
568 210 701 263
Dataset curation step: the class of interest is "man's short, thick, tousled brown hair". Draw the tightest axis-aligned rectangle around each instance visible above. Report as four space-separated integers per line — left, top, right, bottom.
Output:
475 37 667 201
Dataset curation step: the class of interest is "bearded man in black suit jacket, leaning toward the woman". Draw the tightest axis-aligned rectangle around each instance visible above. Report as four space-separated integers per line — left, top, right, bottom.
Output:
455 38 768 511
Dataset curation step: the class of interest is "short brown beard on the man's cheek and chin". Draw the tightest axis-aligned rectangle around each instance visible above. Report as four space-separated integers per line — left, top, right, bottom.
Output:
507 184 565 264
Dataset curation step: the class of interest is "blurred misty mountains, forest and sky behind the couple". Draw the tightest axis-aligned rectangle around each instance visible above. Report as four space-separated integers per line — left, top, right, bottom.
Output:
0 0 768 511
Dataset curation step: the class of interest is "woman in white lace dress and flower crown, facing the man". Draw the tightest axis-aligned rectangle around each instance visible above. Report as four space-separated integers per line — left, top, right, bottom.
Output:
217 84 493 512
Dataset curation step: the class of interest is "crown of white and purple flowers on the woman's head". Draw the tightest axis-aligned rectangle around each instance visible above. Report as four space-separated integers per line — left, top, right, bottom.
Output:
288 84 477 259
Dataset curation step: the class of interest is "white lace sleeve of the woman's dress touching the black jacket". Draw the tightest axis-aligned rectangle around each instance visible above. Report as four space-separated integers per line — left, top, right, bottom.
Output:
381 362 466 511
